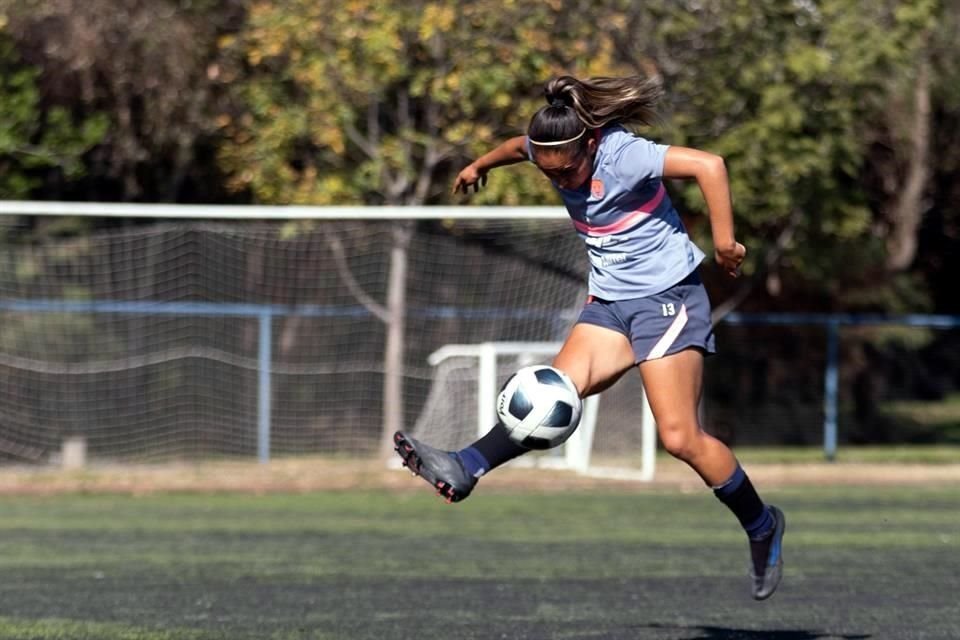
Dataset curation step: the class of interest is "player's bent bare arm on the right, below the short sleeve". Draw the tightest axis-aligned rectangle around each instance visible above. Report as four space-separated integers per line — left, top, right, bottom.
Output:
663 147 747 278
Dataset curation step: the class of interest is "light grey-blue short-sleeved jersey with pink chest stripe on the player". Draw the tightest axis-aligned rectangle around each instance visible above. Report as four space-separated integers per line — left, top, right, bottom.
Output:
527 125 704 300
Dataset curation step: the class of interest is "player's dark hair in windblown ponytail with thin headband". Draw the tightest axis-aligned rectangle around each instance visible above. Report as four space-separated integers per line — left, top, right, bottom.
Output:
527 76 663 151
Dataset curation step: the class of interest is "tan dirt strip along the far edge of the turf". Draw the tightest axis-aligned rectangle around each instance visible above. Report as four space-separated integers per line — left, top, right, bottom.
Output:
0 458 960 496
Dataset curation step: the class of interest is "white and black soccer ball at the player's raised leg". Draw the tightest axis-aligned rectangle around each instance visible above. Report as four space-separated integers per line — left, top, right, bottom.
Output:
497 365 582 449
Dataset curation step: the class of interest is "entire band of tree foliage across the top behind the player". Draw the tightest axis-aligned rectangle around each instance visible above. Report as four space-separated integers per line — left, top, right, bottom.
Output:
0 0 960 309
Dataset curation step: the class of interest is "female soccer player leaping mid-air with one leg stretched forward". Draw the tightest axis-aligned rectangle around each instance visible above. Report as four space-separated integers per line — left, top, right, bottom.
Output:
394 76 786 600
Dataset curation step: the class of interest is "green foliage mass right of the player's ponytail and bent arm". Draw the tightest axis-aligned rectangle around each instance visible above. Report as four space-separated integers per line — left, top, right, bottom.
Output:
658 0 936 298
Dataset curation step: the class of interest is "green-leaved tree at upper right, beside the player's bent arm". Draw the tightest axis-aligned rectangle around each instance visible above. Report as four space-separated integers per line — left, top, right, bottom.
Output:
632 0 937 306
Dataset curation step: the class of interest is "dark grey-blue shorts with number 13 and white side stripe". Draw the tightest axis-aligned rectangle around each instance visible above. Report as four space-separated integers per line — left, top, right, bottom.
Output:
577 271 717 362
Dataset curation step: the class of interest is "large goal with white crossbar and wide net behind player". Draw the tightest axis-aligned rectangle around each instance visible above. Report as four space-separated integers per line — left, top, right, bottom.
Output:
0 202 656 478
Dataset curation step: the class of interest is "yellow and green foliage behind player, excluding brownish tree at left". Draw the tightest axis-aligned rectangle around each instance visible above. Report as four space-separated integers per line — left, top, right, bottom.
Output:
220 0 952 308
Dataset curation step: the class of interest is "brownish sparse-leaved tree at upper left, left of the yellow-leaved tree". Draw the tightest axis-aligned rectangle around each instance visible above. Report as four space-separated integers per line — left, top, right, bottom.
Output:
0 0 243 202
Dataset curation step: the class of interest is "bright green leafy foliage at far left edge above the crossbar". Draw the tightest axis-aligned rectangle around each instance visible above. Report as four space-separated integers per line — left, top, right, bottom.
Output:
0 30 107 199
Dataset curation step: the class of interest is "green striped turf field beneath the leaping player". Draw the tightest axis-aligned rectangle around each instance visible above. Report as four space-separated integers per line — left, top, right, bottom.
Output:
0 478 960 640
